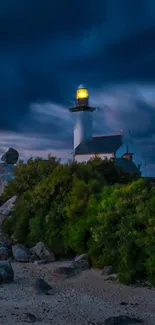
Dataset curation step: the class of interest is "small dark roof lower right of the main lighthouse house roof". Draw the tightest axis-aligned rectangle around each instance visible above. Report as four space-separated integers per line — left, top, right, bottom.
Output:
114 158 140 174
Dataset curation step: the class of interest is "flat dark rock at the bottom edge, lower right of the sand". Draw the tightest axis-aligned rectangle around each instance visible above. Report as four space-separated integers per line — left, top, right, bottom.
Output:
104 316 143 325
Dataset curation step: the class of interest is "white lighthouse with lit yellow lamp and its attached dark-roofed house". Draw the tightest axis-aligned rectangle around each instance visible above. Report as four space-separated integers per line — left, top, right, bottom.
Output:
69 86 141 177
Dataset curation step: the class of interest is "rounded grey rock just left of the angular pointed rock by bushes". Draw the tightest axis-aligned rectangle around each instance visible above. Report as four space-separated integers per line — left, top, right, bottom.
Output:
12 244 32 262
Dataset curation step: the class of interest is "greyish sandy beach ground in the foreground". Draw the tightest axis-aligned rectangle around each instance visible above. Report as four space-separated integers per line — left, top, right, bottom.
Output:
0 262 155 325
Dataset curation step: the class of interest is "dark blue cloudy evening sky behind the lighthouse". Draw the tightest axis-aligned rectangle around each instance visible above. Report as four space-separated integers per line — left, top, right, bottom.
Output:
0 0 155 176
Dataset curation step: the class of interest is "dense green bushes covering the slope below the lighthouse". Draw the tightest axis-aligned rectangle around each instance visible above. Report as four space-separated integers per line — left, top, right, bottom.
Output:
2 156 155 284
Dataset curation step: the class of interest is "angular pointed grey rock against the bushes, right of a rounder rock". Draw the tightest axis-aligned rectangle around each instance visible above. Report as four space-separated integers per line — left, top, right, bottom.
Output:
31 242 55 262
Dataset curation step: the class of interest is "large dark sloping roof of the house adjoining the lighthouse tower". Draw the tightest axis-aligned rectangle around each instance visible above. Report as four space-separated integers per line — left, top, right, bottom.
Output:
75 134 122 155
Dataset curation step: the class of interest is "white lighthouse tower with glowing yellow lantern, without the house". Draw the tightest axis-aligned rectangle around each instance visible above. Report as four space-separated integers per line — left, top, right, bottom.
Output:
70 85 95 150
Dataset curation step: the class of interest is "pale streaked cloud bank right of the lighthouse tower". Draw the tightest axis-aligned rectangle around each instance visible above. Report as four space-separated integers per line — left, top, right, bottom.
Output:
91 85 155 175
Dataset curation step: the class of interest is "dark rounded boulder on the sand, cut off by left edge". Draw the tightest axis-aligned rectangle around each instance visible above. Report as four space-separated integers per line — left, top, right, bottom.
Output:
0 261 14 284
